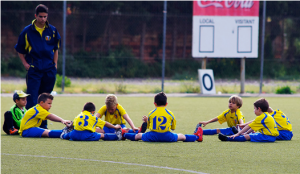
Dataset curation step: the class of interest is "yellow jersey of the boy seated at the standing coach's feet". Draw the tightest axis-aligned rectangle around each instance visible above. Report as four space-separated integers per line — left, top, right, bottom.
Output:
19 104 50 135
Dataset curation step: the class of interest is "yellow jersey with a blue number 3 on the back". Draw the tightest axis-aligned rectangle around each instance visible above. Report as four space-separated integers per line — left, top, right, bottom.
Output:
73 111 105 132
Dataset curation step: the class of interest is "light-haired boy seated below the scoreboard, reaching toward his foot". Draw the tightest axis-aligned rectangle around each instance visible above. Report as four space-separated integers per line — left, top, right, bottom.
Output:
197 95 245 135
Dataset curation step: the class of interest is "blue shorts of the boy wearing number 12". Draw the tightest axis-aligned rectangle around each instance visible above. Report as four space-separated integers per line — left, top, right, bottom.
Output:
142 131 178 142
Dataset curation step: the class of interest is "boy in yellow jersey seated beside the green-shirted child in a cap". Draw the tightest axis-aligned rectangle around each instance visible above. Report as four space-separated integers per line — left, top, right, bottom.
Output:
19 93 71 138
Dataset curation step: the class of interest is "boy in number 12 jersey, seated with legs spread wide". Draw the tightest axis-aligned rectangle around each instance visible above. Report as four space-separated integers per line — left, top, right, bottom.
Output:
124 92 203 142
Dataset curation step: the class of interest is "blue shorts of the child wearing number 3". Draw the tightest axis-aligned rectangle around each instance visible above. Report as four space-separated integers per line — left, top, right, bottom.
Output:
69 130 101 141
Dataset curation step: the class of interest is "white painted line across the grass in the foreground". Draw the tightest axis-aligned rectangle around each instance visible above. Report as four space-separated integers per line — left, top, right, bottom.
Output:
1 153 206 174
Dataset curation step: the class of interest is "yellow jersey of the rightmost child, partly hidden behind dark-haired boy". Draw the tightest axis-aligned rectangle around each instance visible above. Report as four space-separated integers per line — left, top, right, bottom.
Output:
270 109 292 131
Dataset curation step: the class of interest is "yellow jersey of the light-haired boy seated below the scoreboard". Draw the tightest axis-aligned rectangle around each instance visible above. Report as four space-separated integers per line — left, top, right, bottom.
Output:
218 109 245 127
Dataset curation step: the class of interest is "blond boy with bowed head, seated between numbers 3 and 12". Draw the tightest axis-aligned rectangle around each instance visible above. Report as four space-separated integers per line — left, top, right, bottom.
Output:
96 94 147 133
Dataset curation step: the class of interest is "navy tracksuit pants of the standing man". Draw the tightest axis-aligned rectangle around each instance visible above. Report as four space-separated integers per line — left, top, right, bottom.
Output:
26 66 57 129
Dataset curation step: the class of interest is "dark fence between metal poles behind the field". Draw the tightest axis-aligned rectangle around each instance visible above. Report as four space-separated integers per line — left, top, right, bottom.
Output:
1 10 300 79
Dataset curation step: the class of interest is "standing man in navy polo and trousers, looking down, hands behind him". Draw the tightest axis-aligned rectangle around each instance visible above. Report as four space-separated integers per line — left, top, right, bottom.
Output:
15 4 61 128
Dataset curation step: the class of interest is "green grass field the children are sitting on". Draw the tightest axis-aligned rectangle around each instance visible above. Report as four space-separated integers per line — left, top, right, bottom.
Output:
1 96 300 174
